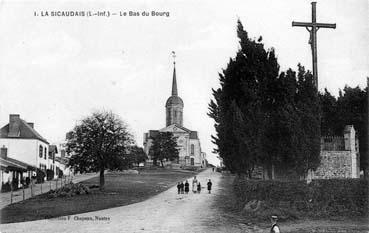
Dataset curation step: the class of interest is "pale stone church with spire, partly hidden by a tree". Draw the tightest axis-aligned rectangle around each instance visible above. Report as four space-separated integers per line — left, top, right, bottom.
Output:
143 58 206 167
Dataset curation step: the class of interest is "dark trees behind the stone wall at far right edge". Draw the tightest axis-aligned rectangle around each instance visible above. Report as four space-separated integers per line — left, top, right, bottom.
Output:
320 86 368 175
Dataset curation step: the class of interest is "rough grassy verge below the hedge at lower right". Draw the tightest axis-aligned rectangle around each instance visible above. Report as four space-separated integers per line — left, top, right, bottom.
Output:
212 174 369 233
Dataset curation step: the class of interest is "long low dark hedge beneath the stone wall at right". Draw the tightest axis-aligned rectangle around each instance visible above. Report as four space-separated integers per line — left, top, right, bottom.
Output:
234 178 369 216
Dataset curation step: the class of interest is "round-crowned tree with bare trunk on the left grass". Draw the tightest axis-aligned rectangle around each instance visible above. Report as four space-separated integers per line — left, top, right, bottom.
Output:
67 111 133 190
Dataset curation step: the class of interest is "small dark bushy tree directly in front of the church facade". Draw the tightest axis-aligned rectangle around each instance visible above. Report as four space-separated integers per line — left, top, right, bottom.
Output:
149 132 179 166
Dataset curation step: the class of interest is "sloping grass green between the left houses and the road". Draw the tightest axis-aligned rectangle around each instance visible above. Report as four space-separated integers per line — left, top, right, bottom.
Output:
0 169 198 224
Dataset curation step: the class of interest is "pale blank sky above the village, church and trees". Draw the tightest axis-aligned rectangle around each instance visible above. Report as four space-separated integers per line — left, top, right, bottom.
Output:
0 0 369 164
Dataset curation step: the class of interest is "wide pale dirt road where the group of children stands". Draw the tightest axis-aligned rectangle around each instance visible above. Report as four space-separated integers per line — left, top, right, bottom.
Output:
0 169 245 233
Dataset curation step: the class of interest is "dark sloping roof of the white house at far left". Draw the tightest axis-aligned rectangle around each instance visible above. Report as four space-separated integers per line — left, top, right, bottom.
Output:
0 118 49 144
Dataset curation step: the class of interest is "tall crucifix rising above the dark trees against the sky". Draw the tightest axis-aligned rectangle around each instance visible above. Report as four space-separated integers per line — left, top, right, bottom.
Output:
292 2 336 90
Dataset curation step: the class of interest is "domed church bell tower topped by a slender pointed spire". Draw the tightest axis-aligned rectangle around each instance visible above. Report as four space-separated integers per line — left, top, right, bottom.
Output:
165 52 183 126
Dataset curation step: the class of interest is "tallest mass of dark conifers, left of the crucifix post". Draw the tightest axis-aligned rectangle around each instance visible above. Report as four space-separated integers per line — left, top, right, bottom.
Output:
208 21 320 177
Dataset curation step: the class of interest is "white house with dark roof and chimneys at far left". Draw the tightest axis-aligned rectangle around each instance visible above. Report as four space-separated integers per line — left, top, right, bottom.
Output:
0 114 50 188
